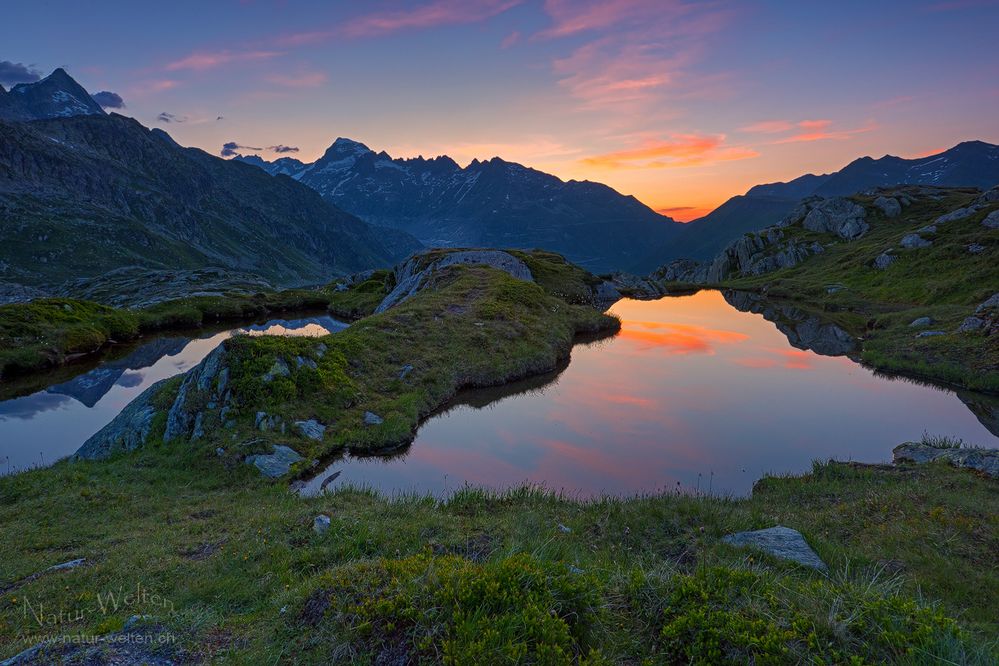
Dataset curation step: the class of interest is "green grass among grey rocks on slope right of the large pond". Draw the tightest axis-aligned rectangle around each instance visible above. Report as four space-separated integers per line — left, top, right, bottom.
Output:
720 188 999 392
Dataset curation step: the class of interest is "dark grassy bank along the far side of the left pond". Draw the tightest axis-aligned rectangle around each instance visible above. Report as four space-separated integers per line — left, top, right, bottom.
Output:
0 290 329 380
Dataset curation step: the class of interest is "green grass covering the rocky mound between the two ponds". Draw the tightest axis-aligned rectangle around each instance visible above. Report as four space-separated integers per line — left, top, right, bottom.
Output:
183 266 620 462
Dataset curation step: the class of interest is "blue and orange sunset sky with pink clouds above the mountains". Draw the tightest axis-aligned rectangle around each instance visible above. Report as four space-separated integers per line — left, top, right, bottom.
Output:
0 0 999 221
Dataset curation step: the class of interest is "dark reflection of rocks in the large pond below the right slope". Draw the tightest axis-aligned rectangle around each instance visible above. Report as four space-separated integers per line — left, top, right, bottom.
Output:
722 291 857 356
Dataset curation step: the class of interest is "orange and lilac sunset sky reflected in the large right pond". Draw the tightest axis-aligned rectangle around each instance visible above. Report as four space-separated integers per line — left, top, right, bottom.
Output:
302 292 995 496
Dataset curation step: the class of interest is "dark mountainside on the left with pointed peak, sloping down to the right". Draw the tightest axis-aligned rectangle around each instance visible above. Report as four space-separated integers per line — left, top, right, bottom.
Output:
0 70 420 288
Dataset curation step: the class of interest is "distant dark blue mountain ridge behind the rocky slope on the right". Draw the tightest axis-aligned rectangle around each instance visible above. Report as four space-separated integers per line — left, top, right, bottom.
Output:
658 141 999 260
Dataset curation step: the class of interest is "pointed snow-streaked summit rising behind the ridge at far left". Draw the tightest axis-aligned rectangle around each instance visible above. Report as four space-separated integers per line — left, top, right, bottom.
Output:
0 68 105 121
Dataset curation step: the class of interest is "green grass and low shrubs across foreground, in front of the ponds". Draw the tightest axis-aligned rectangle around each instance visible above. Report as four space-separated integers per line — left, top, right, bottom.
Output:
0 444 999 663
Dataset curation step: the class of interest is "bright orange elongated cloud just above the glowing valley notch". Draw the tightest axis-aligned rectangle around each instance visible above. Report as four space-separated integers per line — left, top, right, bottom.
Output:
581 134 759 169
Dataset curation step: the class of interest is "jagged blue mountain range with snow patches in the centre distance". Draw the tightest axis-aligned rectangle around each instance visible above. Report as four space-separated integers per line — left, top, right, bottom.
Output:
235 138 682 272
